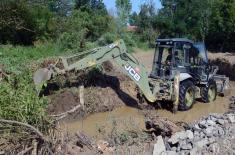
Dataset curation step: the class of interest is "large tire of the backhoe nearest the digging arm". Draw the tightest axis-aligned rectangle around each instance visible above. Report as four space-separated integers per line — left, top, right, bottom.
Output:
178 80 195 111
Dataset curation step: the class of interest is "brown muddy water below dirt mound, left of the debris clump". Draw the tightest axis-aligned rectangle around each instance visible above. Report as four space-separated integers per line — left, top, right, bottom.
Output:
62 106 144 137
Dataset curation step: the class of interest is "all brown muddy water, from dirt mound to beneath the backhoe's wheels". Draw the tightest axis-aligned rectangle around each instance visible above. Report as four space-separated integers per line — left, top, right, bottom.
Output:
62 82 235 137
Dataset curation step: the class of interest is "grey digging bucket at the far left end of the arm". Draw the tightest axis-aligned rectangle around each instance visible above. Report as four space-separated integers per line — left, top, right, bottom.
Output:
33 68 53 92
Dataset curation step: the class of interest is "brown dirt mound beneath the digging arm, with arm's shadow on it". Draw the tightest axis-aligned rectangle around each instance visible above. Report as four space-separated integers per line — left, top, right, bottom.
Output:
45 64 137 119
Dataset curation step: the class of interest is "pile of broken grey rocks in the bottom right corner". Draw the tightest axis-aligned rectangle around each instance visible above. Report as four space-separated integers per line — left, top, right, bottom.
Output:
153 97 235 155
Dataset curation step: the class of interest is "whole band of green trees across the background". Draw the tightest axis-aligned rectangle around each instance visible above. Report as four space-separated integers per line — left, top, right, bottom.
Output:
0 0 235 51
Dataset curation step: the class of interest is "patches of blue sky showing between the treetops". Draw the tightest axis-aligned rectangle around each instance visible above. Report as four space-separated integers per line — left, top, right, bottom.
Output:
103 0 161 12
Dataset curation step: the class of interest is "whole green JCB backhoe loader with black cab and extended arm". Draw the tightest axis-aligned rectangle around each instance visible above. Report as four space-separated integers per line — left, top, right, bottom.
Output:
34 38 229 111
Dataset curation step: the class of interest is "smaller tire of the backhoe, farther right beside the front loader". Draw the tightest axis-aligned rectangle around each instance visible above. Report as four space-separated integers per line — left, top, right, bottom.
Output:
201 80 217 103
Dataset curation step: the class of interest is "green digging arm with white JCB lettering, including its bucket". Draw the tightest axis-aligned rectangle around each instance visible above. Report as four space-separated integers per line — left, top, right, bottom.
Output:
34 40 156 102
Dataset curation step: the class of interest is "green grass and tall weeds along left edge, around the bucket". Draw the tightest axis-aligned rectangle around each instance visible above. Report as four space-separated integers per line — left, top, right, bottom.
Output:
0 43 61 131
